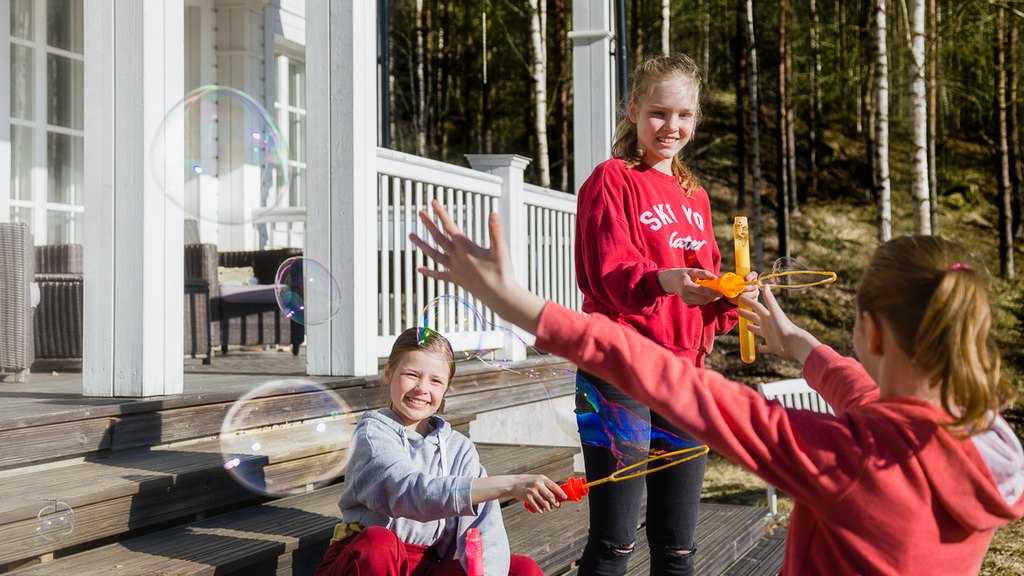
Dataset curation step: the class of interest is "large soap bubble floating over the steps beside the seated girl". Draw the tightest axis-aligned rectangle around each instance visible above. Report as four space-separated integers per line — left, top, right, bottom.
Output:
220 379 355 497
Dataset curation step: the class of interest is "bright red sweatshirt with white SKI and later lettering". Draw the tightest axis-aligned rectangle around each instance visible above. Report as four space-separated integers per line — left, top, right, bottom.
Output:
575 158 737 366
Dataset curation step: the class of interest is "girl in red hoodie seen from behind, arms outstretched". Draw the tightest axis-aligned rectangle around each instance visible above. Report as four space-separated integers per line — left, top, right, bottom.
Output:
414 204 1024 575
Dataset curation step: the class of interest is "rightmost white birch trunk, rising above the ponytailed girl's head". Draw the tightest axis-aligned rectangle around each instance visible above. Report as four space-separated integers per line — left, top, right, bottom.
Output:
910 0 932 234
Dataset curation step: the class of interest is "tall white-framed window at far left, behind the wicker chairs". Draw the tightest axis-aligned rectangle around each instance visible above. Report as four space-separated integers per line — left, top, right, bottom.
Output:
5 0 85 244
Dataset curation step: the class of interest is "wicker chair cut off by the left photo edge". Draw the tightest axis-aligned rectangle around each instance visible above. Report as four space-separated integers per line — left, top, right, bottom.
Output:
0 222 34 382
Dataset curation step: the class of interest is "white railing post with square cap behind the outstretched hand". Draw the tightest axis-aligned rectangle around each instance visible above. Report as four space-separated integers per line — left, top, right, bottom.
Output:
466 154 532 361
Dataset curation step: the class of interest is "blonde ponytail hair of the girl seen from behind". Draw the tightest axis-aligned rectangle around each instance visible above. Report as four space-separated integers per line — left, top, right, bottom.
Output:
857 236 1015 436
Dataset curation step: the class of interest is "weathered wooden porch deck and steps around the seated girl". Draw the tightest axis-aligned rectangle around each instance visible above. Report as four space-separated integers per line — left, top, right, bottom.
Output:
0 352 782 576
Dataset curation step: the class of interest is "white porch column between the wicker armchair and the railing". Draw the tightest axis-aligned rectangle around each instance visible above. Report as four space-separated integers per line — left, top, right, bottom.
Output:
306 0 378 375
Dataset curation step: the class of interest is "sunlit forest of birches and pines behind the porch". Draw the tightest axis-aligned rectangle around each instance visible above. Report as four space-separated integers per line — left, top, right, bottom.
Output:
378 0 1024 574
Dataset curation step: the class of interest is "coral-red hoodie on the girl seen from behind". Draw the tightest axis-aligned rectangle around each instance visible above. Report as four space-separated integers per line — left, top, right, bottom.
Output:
537 302 1024 576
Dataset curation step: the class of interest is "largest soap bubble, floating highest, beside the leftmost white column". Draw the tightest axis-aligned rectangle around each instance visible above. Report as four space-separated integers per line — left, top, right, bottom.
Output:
150 85 290 224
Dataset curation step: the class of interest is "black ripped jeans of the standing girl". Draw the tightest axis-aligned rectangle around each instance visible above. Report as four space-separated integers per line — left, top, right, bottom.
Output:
577 370 708 576
